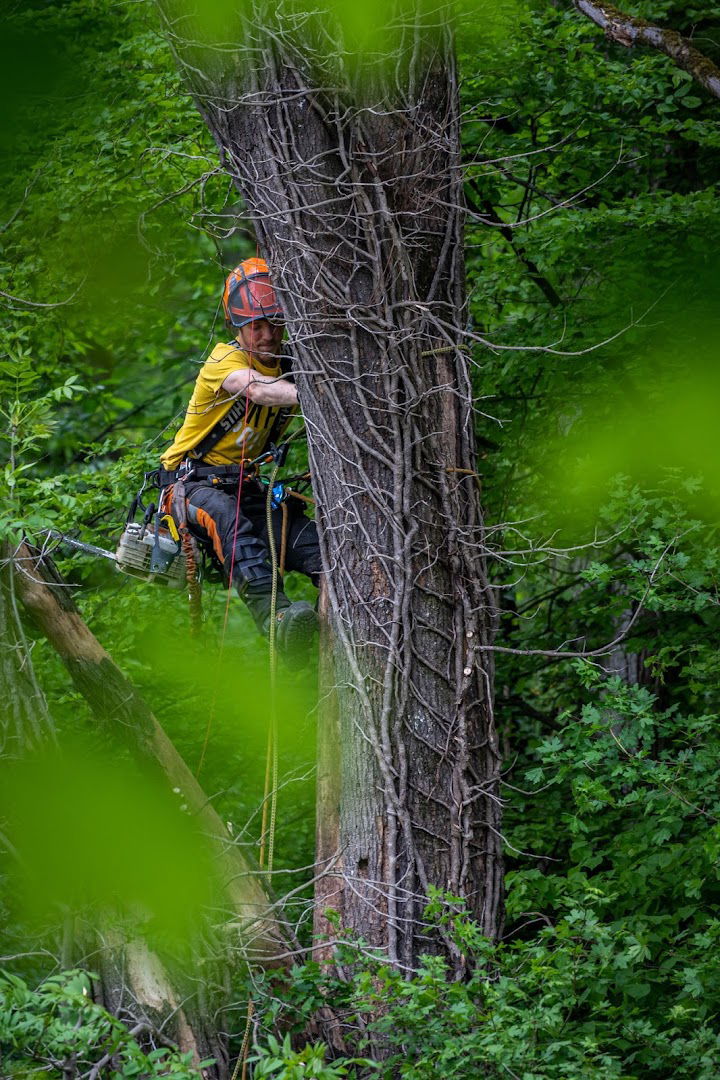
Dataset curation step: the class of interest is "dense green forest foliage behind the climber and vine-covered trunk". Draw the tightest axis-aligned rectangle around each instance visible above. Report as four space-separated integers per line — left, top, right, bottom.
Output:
0 0 720 1080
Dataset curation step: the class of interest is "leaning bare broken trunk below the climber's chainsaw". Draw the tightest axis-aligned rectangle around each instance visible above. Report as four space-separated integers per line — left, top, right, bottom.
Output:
15 544 294 964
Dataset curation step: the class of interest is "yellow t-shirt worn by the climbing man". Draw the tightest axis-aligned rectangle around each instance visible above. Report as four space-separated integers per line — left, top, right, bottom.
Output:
161 345 296 469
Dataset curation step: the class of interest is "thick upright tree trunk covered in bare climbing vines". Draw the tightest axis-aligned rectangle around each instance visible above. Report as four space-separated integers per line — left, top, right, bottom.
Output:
161 0 502 969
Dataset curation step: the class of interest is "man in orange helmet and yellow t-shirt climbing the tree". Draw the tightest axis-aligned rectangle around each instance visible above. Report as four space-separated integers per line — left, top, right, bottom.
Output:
160 258 321 657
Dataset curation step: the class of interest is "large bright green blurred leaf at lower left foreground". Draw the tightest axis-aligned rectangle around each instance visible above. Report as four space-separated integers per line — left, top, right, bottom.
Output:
0 745 220 937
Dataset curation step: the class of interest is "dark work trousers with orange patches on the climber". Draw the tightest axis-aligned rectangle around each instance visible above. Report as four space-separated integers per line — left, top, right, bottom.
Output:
186 481 321 630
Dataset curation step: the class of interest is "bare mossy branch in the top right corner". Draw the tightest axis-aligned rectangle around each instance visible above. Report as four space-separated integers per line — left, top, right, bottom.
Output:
573 0 720 97
